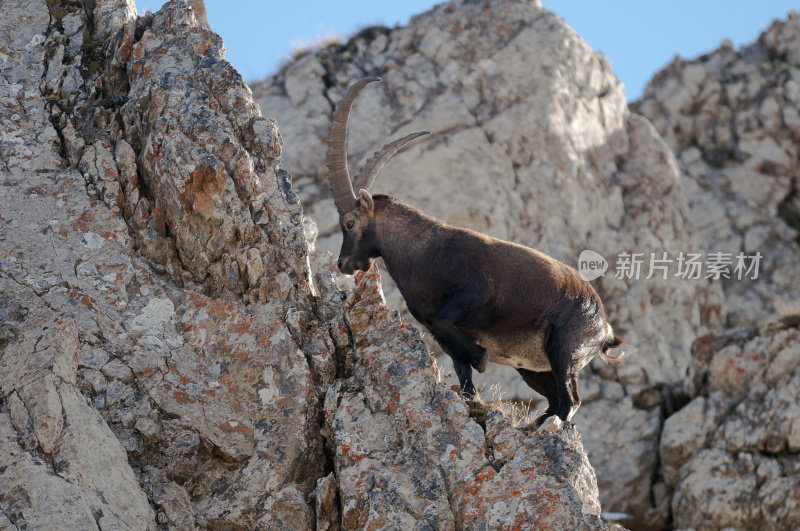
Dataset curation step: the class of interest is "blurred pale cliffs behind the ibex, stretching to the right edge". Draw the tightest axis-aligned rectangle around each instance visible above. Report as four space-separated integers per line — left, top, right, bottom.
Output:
253 0 800 528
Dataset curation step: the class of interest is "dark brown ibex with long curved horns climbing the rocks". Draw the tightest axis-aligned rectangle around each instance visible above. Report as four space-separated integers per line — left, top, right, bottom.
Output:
328 77 622 424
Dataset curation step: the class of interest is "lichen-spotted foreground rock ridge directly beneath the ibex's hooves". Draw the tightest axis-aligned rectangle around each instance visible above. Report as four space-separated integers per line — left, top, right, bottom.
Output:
325 269 606 529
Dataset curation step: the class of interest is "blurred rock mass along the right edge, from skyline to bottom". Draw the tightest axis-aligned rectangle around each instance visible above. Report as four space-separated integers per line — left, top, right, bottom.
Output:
632 13 800 529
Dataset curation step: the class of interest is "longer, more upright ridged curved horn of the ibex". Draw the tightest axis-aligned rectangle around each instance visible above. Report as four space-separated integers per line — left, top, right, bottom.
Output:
328 77 381 215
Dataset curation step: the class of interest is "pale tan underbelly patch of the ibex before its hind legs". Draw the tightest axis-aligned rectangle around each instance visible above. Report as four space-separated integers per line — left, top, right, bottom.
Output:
475 330 550 372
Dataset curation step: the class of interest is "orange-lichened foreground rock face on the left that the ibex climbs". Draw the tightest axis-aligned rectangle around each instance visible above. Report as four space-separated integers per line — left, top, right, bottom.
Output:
0 0 606 529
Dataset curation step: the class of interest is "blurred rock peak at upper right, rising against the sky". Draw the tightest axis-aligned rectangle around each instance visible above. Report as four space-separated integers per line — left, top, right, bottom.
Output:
632 14 800 326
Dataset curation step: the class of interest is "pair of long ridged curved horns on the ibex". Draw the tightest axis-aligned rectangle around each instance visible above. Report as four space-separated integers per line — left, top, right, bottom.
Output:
328 77 430 214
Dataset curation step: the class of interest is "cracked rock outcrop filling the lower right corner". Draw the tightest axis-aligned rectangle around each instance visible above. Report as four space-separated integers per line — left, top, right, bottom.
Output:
659 318 800 529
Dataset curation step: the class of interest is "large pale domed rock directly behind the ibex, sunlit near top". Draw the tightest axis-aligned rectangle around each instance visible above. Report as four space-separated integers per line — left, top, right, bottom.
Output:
253 0 721 521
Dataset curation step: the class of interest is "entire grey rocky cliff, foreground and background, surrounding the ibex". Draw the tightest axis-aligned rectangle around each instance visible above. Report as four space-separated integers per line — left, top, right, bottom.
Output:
0 0 800 529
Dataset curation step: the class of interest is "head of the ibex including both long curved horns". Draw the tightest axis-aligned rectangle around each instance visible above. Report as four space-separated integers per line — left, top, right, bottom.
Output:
328 77 430 275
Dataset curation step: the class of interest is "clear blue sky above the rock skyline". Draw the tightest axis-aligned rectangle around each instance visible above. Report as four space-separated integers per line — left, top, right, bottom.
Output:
136 0 800 100
